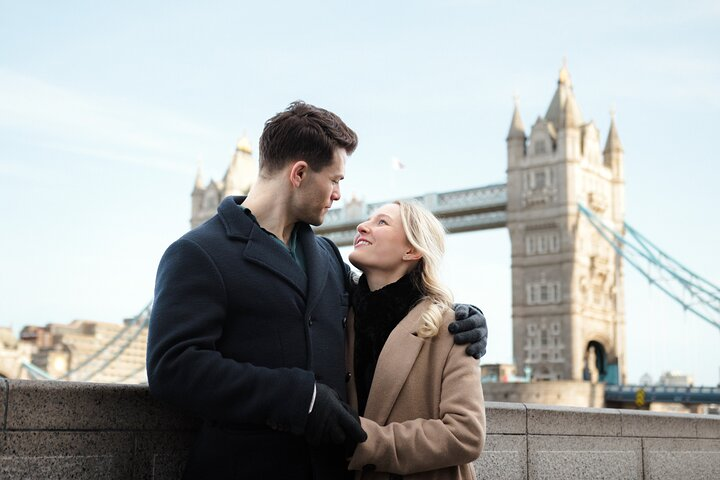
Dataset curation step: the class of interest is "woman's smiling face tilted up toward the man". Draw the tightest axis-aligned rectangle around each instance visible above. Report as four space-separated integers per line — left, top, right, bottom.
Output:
349 203 417 278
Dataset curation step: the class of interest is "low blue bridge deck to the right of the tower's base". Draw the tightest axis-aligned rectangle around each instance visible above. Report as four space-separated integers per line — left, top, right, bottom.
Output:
605 385 720 405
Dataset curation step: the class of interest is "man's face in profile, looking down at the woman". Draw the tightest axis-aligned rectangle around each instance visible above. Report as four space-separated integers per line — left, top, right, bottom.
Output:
296 148 347 225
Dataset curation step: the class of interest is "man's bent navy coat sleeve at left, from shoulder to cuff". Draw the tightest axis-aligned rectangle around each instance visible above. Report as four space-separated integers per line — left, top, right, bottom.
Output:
147 239 315 433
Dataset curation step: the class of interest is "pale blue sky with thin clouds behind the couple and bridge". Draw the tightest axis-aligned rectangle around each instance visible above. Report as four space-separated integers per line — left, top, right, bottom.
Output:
0 0 720 385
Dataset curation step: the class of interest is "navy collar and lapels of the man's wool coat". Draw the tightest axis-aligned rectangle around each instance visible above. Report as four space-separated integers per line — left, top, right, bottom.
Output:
218 196 332 314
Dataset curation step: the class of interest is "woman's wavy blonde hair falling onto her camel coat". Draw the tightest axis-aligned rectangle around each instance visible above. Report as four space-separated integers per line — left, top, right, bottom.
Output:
394 200 453 338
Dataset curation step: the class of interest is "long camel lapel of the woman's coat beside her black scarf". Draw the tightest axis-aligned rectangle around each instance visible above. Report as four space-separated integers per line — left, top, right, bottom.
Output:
365 301 426 425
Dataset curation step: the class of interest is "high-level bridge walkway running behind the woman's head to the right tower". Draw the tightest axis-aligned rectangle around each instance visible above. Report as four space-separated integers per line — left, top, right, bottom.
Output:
315 183 507 247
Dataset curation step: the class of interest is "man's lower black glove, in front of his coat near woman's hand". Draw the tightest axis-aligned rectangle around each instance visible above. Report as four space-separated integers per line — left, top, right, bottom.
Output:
305 383 367 447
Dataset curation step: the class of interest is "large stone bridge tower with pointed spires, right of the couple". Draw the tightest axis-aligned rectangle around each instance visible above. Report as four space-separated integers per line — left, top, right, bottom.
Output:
507 66 625 383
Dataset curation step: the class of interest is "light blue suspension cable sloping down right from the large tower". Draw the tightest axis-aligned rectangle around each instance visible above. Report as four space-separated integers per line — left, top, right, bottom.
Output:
578 203 720 330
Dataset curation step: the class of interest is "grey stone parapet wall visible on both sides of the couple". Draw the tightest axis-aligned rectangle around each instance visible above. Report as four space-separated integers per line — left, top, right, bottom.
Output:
0 379 720 480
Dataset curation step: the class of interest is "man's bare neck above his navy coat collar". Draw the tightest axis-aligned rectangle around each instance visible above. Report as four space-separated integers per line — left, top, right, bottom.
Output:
243 175 297 244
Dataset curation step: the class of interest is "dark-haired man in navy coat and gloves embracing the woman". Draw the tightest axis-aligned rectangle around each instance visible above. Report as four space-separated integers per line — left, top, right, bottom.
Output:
147 102 486 480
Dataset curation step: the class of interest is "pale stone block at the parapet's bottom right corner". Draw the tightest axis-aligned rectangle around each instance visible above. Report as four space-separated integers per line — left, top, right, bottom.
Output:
643 438 720 480
